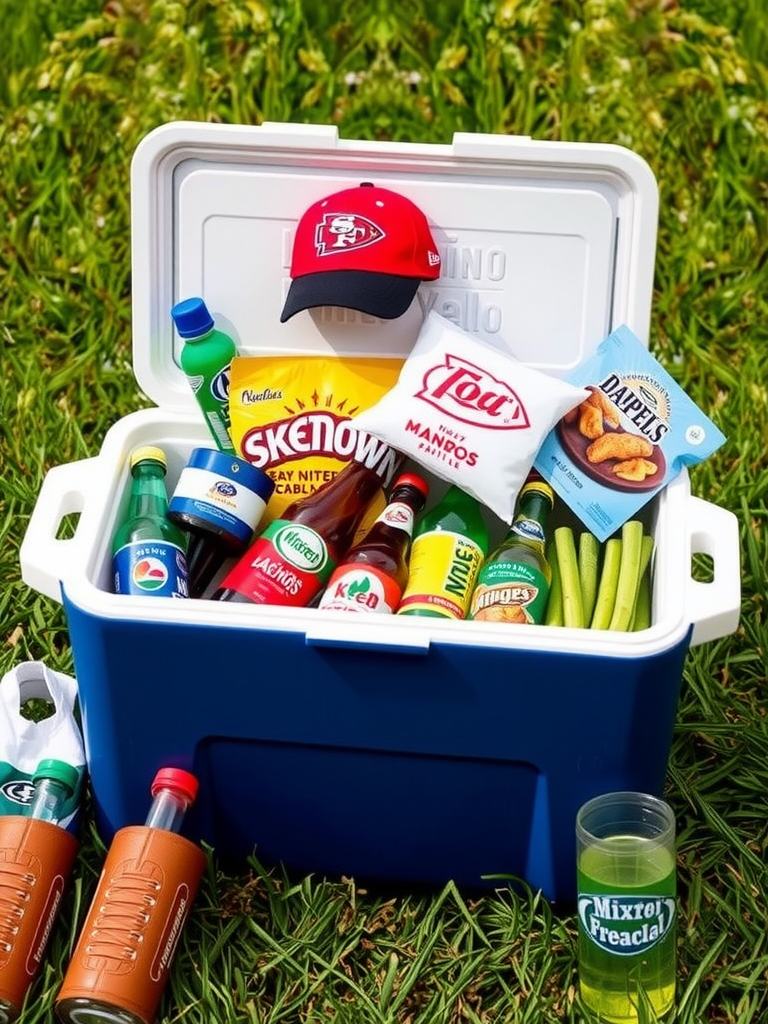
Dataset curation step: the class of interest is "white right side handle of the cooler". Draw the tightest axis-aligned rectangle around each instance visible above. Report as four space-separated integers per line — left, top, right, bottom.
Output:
686 496 741 646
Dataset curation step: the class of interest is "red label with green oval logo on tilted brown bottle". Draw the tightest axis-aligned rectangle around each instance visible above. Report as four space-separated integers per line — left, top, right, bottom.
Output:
221 519 335 608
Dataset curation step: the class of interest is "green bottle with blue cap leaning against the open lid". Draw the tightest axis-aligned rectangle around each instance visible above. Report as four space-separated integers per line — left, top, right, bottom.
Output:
171 297 238 455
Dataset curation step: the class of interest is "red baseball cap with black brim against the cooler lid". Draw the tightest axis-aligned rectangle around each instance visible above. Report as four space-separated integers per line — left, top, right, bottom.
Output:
280 181 440 324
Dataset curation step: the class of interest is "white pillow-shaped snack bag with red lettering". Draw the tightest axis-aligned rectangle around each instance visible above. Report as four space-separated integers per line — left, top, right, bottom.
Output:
354 310 588 523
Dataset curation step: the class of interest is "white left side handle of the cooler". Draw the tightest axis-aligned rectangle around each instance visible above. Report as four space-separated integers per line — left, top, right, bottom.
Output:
18 459 98 601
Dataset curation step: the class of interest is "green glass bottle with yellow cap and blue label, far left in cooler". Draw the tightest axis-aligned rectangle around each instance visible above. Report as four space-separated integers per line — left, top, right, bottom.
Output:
112 444 189 597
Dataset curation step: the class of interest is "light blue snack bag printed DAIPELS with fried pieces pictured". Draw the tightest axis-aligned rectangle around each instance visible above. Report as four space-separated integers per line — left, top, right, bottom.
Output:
534 326 725 541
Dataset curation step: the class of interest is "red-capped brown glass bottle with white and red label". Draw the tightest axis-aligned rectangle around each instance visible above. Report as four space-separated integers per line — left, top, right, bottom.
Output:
318 473 429 614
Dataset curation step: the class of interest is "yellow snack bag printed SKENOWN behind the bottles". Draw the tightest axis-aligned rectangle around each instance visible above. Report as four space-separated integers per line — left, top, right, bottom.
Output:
229 355 403 527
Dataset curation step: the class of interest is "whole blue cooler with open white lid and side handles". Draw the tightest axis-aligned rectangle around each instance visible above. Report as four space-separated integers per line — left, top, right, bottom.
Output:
20 123 740 900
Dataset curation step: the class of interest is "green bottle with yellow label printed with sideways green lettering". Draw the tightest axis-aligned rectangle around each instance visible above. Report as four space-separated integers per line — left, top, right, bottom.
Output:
397 484 489 618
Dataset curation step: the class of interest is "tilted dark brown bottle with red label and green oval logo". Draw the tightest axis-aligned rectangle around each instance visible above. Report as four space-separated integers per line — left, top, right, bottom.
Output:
213 444 402 607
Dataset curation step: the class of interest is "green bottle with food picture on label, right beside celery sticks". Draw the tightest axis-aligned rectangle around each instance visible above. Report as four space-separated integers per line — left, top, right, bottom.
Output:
467 472 554 625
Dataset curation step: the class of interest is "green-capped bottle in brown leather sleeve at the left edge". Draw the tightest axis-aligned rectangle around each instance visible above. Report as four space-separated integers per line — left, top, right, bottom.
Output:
0 759 80 1024
